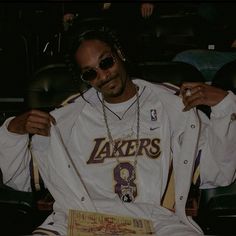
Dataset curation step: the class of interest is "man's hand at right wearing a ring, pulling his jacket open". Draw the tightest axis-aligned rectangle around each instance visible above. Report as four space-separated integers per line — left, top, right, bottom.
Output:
180 82 228 111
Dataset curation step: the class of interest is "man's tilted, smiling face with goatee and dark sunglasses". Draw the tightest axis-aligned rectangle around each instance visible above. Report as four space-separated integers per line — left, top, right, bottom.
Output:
75 40 127 102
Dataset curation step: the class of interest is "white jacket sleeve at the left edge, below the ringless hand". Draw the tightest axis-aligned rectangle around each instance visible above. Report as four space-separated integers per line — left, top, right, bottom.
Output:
0 118 31 191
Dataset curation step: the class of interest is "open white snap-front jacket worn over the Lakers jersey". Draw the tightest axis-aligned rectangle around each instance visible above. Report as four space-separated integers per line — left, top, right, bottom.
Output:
0 80 236 235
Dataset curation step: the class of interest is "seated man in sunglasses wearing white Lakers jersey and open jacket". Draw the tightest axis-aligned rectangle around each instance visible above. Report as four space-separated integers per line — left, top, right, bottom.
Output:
0 31 236 236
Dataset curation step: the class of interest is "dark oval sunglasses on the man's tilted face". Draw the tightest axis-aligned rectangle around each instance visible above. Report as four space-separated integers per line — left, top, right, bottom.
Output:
80 56 115 82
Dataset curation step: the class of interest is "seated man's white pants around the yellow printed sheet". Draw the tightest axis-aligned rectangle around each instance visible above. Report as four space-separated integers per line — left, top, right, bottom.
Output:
34 199 202 236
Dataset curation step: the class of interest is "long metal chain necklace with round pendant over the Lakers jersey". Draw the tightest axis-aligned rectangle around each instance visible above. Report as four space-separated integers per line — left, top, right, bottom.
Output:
102 85 140 202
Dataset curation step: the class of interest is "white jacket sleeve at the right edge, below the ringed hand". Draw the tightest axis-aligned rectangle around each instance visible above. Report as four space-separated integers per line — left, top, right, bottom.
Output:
200 92 236 188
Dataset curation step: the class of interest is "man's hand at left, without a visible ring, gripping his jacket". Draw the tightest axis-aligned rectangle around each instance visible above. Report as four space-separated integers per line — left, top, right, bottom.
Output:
7 110 56 136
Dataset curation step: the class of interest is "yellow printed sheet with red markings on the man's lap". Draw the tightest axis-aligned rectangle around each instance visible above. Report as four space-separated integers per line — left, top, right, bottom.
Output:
67 210 154 236
